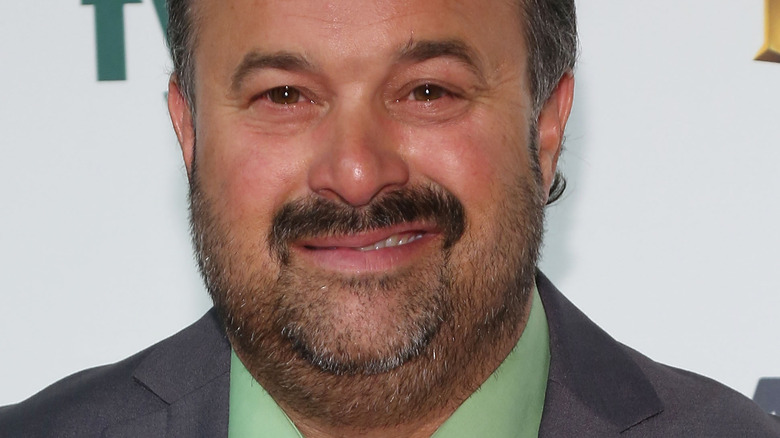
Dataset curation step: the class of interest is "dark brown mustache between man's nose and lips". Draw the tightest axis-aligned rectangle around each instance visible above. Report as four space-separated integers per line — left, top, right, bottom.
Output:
268 185 466 263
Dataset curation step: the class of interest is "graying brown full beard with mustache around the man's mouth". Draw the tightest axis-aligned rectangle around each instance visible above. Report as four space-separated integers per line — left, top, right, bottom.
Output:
190 140 544 429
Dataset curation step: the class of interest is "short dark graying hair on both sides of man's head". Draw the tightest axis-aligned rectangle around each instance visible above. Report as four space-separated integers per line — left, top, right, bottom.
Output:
166 0 577 203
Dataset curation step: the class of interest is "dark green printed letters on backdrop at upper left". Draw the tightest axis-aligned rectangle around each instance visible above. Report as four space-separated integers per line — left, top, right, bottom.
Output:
81 0 168 81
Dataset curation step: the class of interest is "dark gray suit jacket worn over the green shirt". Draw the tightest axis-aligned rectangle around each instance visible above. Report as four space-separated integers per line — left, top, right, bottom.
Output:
0 274 780 438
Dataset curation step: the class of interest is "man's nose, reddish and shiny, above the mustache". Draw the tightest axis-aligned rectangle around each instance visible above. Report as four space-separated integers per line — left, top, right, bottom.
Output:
308 105 409 207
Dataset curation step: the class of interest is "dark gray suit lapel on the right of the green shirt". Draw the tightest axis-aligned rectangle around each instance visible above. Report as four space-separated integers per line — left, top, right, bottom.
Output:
537 273 663 437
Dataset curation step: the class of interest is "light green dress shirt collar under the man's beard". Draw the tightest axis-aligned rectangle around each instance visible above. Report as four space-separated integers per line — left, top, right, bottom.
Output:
228 287 550 438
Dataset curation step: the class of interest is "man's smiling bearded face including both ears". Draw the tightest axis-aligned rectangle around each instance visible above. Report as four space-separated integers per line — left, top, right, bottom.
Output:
171 0 570 428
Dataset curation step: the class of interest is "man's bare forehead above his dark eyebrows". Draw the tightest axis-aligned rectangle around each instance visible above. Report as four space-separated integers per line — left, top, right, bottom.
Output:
195 0 526 80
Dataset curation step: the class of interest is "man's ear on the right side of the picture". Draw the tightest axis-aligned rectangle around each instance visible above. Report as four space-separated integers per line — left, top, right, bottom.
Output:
536 72 574 203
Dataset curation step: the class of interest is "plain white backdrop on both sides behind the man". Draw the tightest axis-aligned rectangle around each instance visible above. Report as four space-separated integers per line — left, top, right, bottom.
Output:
0 0 780 405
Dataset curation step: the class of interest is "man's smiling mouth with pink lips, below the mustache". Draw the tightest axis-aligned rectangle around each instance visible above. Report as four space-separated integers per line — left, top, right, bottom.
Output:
292 234 436 275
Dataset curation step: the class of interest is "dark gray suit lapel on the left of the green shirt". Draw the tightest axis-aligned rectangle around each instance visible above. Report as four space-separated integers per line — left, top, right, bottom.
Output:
103 310 230 438
